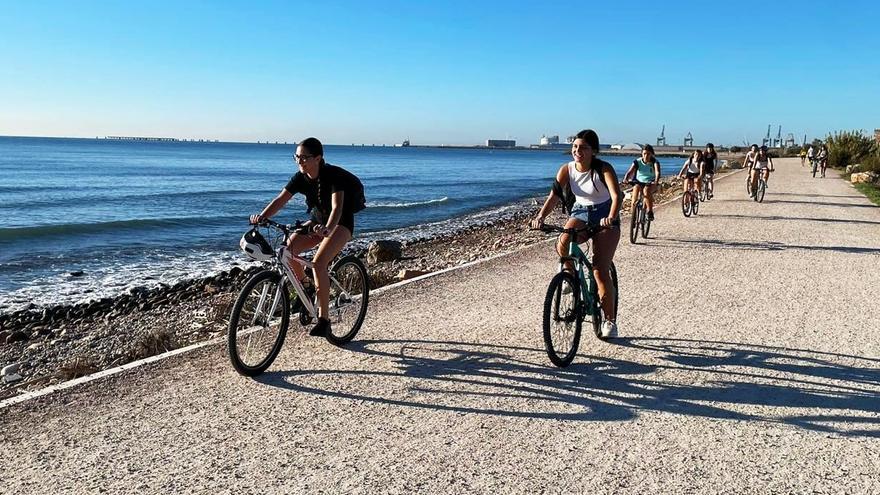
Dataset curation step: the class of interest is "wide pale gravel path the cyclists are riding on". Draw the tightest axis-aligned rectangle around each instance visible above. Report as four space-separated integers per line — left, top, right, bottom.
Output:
0 159 880 494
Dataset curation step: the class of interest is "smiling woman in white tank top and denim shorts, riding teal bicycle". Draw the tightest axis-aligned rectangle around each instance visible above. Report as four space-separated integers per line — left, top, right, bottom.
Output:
530 129 623 338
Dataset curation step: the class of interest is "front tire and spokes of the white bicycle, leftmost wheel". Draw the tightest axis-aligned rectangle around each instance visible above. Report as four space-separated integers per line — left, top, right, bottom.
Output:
227 270 290 376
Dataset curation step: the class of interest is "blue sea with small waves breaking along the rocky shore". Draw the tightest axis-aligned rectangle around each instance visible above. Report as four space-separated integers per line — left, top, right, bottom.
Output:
0 137 679 312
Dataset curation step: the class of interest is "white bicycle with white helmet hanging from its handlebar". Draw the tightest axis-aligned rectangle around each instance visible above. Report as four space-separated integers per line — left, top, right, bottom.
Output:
228 220 370 376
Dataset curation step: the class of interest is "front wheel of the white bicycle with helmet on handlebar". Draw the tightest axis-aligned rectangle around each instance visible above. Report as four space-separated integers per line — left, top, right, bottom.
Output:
227 270 290 376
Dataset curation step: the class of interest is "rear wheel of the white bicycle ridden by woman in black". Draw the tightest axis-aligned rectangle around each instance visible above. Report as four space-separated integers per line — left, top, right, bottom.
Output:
327 256 370 346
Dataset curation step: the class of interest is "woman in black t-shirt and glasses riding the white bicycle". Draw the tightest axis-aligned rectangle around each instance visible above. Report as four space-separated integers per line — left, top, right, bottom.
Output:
250 138 364 335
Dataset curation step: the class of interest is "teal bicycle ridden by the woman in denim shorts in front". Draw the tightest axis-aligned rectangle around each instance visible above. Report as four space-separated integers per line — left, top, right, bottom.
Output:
541 225 617 368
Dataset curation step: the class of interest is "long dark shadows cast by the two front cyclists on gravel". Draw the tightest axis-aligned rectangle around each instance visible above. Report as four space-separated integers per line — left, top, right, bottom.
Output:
258 338 880 437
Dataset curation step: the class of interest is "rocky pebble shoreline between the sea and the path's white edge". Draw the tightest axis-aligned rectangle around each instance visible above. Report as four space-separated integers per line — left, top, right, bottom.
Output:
0 172 720 399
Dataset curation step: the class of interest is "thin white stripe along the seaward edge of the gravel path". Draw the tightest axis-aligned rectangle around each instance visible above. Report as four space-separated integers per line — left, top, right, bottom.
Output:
0 169 744 409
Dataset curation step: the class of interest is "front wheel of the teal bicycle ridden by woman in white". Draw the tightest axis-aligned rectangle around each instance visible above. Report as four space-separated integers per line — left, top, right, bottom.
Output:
543 271 584 368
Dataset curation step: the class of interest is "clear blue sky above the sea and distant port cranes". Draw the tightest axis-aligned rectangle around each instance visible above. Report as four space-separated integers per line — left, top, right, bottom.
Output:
0 0 880 144
